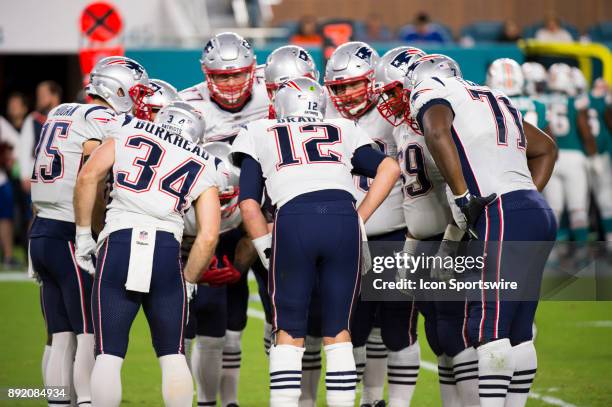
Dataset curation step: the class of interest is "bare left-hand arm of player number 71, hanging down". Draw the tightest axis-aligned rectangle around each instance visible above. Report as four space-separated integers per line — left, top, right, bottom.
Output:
423 105 467 195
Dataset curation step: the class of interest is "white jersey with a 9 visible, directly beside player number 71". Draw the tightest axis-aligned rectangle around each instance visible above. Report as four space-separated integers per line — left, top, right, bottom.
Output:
393 124 453 240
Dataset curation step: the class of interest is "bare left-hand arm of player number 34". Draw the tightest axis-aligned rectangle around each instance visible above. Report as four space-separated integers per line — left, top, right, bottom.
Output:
74 139 115 227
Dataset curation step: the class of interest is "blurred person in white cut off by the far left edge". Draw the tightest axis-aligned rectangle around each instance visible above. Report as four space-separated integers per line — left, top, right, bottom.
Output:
0 116 19 268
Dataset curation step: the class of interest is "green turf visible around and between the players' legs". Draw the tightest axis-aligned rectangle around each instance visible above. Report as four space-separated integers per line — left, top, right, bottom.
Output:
0 282 612 407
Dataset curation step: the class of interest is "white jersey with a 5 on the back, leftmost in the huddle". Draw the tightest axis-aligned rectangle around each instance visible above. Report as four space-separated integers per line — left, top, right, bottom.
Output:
31 103 117 222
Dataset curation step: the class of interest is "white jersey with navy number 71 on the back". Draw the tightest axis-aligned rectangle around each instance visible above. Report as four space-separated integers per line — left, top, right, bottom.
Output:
410 77 536 196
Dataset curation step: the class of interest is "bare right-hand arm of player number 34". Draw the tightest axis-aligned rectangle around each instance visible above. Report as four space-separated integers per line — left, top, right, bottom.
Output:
183 187 221 284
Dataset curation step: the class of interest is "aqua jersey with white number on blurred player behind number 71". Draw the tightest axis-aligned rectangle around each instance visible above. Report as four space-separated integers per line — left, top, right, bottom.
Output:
543 93 589 152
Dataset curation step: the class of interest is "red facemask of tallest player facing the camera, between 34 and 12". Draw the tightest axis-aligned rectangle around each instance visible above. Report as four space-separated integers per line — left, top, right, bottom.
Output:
203 63 255 109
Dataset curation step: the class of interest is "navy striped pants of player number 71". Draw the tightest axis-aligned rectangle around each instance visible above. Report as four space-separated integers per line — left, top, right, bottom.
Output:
468 190 557 346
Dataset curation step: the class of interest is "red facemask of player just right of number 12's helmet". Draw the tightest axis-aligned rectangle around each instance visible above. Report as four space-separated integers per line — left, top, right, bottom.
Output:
325 71 377 119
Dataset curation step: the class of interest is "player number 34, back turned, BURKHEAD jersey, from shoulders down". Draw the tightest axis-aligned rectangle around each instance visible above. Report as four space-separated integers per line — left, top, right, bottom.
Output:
74 95 220 407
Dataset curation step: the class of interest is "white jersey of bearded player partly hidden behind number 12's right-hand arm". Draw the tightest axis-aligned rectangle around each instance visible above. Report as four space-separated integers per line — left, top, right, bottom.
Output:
325 100 406 236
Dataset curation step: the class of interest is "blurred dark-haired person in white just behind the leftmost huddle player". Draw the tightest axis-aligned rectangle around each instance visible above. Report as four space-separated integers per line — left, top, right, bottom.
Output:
19 81 62 194
